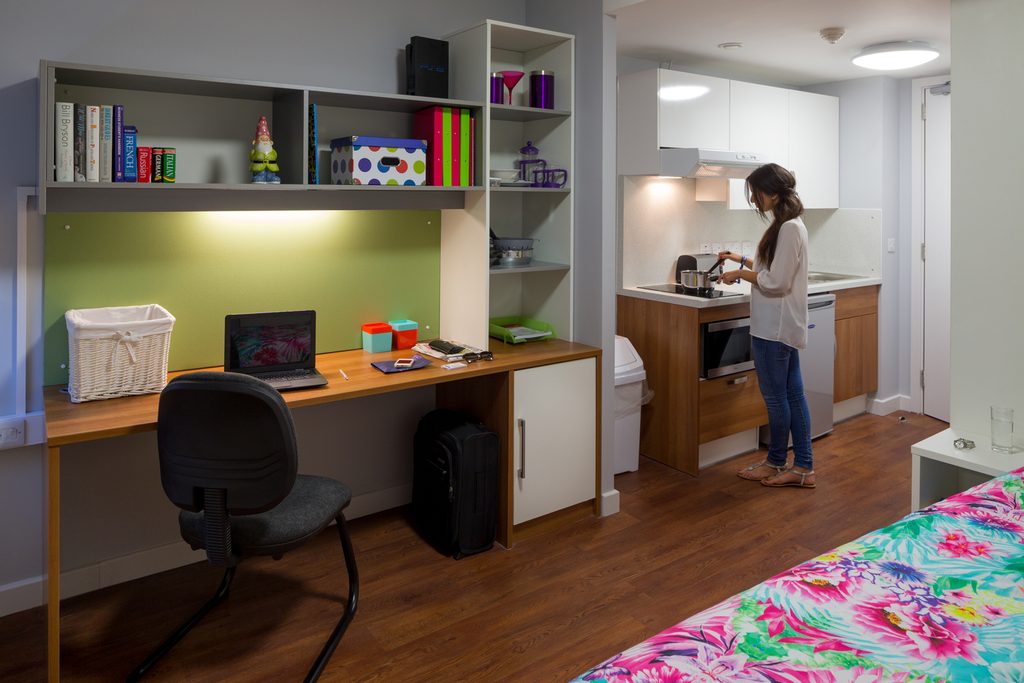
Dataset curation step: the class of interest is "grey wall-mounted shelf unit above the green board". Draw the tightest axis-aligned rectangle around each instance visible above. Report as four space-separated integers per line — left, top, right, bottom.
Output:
39 61 483 213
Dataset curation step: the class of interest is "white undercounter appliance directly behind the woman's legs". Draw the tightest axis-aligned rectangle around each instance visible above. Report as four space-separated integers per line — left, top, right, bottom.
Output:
759 294 836 446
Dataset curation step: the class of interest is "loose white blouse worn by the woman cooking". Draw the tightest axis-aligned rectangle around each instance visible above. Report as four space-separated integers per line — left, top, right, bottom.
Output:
751 217 807 348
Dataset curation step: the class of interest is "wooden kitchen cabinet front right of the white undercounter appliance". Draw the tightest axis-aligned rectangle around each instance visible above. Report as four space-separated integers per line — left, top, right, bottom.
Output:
833 286 879 403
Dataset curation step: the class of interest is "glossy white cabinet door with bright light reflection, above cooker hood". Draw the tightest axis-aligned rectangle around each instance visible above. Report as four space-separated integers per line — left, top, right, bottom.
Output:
655 69 730 150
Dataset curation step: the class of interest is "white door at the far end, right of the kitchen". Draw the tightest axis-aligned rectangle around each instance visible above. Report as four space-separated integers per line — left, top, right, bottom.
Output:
922 86 951 422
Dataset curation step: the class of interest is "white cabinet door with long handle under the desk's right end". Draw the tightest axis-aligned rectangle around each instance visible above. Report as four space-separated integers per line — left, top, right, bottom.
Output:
512 358 597 524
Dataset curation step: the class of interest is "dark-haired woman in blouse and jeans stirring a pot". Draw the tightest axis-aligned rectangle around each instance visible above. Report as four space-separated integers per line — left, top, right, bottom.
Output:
719 164 816 488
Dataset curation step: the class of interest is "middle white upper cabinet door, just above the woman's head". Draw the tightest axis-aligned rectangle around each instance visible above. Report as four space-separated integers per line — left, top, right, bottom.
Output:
729 81 790 209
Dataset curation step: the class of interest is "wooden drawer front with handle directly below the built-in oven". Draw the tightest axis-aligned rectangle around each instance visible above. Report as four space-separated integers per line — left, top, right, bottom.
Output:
698 370 768 443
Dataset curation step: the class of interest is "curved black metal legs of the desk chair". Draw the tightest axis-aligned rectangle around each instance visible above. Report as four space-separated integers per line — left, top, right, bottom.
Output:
126 513 359 683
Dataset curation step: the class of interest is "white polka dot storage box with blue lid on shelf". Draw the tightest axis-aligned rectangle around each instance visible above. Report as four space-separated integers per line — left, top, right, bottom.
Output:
331 135 427 185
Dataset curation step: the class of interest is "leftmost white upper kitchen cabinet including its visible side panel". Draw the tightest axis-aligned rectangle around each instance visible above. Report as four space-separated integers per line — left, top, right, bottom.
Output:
617 69 729 175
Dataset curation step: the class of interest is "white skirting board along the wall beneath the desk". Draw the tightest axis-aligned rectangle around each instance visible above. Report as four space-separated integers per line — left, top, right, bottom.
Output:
0 484 411 616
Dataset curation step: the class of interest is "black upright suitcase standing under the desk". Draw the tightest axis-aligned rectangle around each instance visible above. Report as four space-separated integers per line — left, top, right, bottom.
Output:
412 410 498 559
